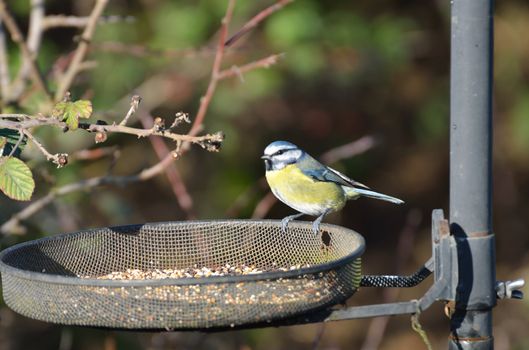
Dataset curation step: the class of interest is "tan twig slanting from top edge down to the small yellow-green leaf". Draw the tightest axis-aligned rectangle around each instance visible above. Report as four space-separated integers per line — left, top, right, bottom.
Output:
55 0 108 101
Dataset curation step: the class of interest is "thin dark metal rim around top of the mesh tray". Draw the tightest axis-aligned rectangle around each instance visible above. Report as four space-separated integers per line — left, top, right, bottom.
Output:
0 219 365 287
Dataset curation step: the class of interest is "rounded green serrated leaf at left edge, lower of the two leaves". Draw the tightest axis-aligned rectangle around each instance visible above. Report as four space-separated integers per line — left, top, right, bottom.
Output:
0 157 35 201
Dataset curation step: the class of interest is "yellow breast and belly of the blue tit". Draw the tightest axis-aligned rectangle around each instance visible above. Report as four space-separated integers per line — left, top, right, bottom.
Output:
266 164 346 216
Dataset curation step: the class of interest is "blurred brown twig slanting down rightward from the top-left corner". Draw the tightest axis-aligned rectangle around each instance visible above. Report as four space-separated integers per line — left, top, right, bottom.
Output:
0 0 51 101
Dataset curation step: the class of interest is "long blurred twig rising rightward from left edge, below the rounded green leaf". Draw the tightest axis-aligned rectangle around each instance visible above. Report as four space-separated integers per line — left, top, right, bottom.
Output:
0 154 174 234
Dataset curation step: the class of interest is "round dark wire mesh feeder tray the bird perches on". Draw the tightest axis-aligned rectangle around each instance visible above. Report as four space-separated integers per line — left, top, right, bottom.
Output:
0 220 364 329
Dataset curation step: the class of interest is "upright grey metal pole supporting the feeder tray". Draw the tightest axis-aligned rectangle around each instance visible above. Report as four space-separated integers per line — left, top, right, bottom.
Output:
449 0 496 349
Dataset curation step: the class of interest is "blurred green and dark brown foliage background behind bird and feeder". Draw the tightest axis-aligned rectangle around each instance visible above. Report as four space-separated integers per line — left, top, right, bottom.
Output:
0 0 529 350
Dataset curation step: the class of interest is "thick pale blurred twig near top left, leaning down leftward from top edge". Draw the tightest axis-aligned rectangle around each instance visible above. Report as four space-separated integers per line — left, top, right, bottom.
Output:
10 0 45 101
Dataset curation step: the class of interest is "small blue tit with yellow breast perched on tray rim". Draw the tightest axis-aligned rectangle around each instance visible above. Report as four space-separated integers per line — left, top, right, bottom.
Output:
261 141 404 233
